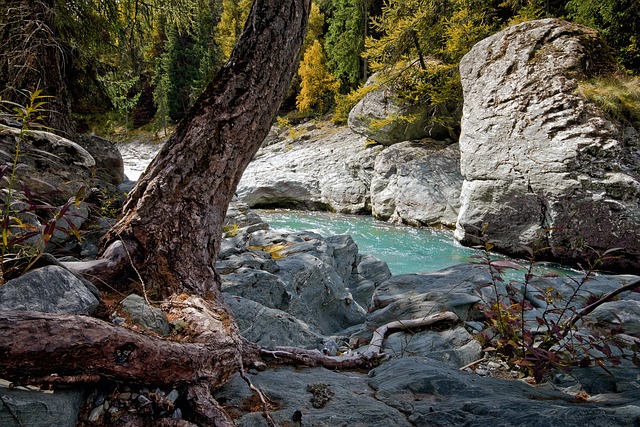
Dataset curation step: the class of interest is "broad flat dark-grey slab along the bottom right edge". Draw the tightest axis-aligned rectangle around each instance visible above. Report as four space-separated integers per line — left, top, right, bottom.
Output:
215 357 640 427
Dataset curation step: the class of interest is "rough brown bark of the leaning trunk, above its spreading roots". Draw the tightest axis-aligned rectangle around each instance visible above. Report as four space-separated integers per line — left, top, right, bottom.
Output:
105 0 310 298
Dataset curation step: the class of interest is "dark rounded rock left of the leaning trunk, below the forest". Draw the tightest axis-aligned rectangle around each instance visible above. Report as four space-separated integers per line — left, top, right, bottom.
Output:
76 135 125 185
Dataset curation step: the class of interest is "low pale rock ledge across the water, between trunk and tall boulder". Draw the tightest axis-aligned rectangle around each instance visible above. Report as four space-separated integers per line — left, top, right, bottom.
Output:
237 124 462 227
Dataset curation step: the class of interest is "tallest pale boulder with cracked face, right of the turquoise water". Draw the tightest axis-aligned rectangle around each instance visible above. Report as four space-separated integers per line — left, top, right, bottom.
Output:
456 19 640 270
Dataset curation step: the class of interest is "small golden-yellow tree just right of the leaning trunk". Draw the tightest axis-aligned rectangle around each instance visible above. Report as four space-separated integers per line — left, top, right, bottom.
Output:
296 39 340 113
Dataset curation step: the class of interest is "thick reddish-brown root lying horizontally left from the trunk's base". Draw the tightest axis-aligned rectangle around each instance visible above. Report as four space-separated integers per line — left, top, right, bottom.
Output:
0 297 250 387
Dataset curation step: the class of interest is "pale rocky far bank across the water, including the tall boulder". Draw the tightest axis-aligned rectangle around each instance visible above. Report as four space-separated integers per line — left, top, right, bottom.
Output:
238 19 640 273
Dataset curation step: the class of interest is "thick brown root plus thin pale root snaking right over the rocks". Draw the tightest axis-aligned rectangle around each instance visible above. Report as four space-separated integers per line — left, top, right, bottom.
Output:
0 306 459 386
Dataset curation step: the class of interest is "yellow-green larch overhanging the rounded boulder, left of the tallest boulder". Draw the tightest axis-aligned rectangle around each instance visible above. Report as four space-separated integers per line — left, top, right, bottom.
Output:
366 0 496 137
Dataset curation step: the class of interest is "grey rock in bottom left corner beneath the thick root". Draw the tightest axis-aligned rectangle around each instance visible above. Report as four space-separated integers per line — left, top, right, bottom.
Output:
0 386 85 427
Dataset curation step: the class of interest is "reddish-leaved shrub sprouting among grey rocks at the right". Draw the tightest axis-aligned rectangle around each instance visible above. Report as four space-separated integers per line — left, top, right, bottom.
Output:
474 229 640 383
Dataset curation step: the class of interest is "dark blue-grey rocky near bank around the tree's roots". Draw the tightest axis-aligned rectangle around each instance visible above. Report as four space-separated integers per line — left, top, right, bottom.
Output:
0 201 640 426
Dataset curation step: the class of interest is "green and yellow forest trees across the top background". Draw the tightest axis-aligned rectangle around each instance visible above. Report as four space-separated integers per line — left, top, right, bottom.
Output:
0 0 640 135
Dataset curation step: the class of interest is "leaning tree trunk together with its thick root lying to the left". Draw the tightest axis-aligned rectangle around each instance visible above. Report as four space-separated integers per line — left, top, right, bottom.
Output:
0 0 311 424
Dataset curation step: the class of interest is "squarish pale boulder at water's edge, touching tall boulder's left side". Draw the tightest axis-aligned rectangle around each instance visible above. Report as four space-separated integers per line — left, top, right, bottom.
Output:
371 142 462 227
